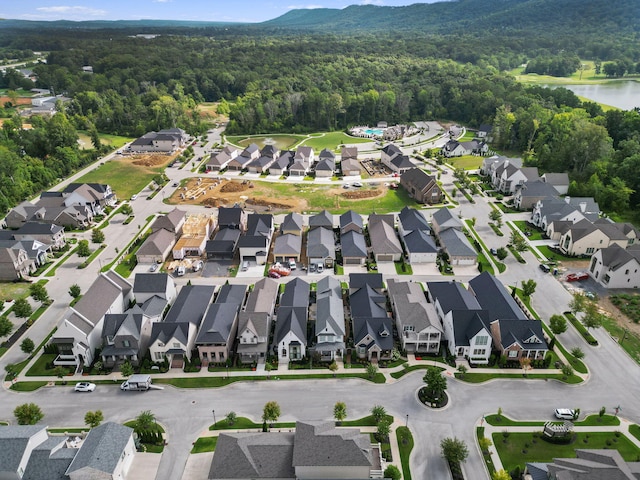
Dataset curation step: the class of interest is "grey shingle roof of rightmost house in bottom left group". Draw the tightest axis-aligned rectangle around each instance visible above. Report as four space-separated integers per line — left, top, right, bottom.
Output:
67 422 133 475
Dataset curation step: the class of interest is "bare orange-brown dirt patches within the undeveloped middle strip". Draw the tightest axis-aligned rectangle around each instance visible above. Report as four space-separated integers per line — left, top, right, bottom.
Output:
165 177 387 213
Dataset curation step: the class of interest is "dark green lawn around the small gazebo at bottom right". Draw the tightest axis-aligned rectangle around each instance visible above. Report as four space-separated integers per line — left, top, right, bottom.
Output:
492 432 640 471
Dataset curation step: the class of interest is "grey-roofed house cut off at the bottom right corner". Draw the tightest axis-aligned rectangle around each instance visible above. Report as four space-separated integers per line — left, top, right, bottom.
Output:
524 448 640 480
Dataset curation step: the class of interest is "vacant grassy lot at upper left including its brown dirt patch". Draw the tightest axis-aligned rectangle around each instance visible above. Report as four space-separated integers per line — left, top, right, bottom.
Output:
77 155 174 199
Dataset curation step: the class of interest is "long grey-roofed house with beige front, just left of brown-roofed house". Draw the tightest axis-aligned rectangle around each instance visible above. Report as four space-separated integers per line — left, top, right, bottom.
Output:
195 284 247 366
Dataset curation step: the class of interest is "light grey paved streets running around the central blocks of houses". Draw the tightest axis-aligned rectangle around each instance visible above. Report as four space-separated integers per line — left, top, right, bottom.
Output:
0 128 640 480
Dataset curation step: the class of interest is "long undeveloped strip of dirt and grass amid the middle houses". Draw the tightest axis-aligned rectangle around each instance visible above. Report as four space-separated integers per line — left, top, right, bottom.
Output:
167 177 415 213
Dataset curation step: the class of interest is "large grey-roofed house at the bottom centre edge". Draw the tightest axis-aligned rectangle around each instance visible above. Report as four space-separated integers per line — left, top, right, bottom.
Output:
208 421 384 480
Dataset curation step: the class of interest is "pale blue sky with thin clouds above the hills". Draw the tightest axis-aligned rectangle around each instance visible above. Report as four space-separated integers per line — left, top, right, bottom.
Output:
0 0 437 22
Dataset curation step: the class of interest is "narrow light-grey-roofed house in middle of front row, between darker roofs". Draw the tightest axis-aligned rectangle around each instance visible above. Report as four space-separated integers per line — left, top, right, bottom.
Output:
313 276 346 361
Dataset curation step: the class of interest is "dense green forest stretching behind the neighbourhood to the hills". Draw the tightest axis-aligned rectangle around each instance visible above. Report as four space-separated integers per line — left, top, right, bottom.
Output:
0 0 640 216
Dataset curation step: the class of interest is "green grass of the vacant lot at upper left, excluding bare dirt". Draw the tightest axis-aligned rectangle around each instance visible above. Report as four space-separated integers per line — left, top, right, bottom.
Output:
77 157 171 199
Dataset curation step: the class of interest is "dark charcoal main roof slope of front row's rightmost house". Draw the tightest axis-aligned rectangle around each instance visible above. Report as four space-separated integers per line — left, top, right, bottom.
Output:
469 272 527 320
